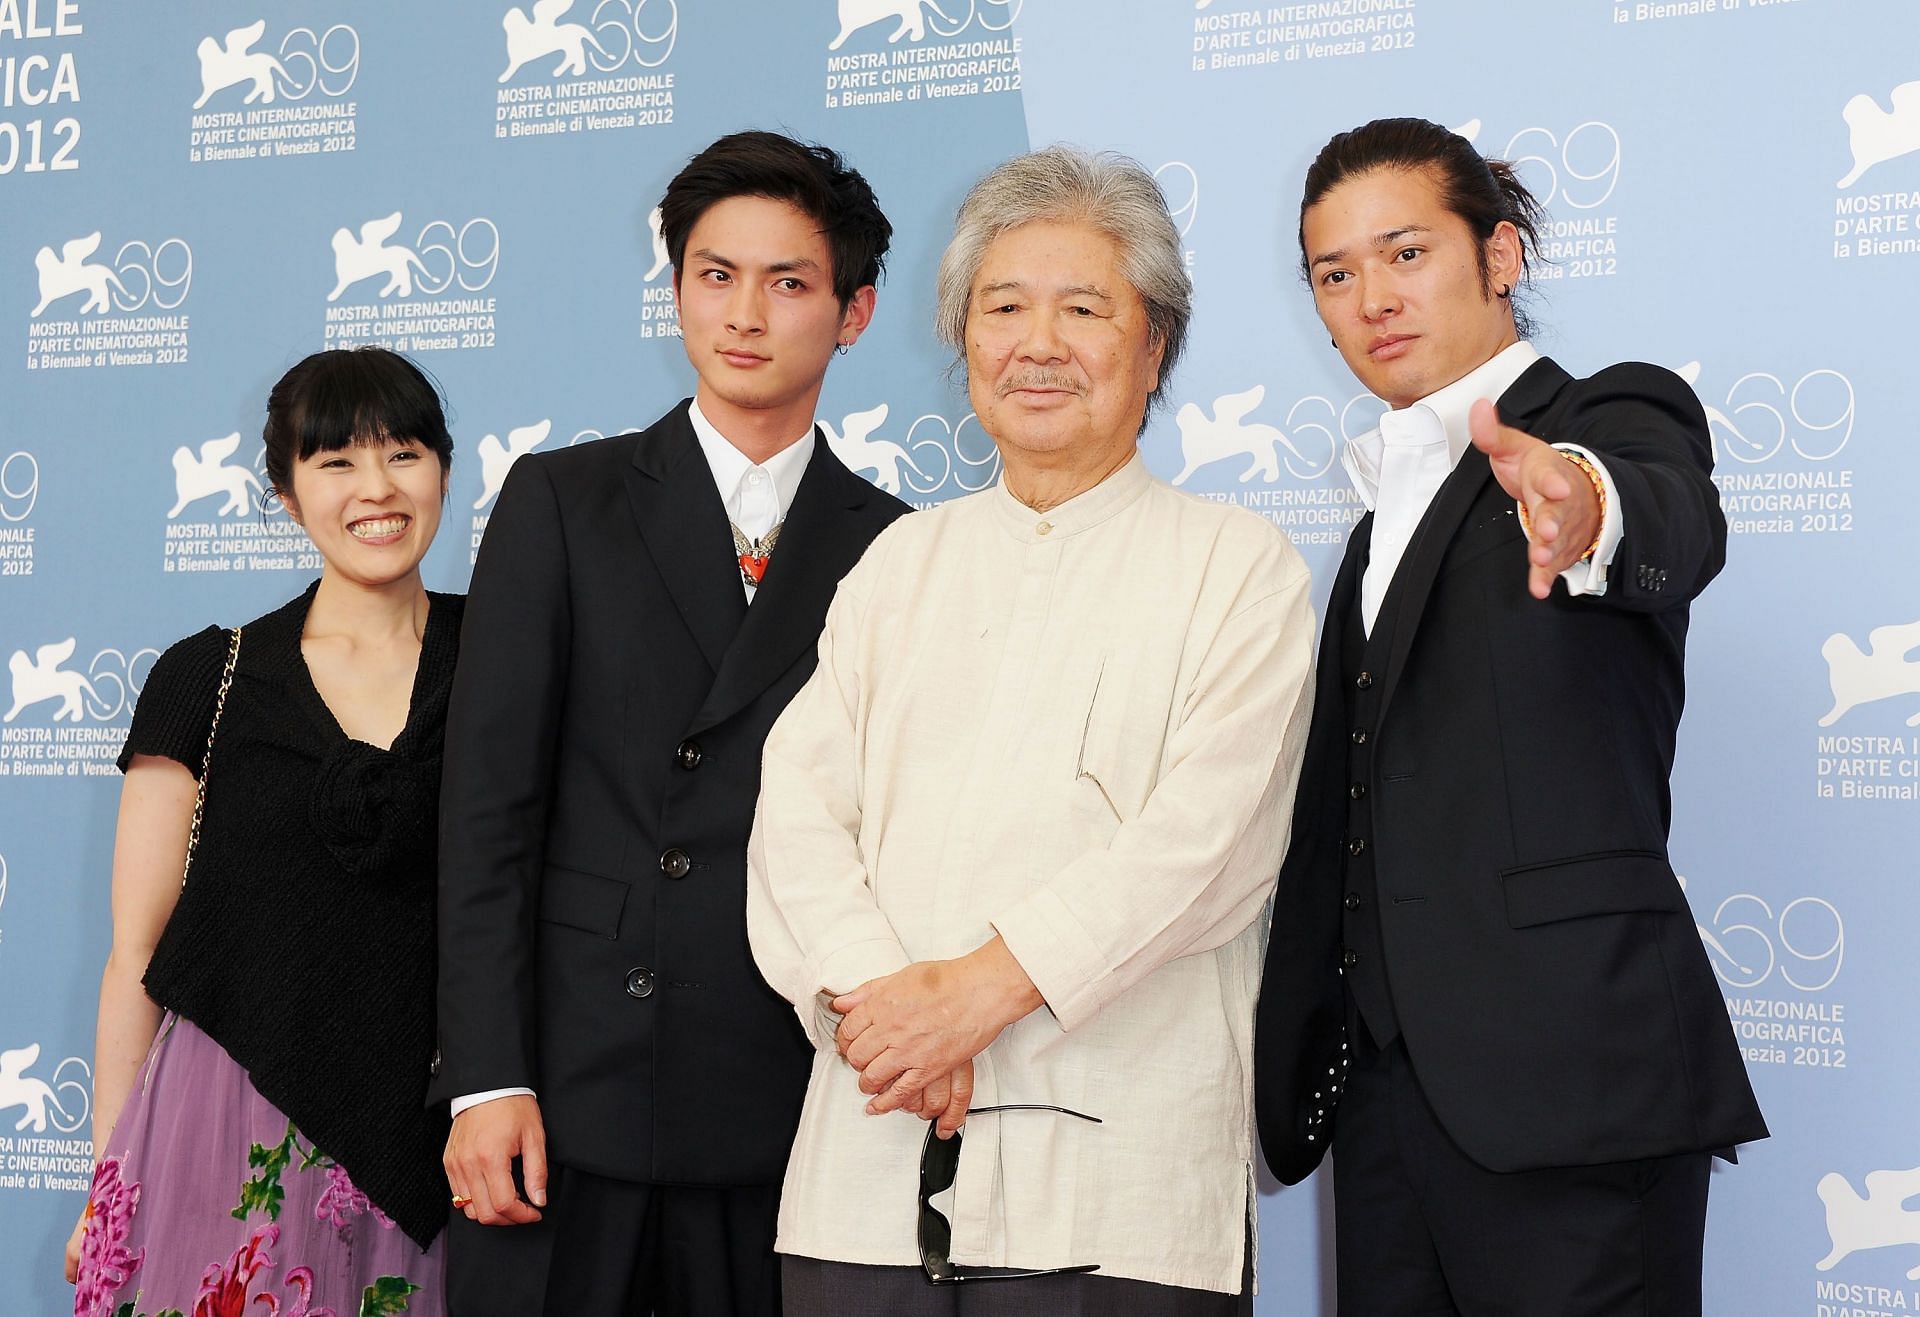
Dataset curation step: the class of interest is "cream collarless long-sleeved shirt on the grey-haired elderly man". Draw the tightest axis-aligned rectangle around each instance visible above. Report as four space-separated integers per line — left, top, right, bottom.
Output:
747 455 1313 1294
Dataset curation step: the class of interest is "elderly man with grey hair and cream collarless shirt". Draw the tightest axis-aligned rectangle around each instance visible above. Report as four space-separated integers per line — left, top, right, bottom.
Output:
747 146 1313 1317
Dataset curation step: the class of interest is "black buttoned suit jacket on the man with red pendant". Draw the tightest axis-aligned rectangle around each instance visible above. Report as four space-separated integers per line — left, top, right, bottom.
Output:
432 403 908 1185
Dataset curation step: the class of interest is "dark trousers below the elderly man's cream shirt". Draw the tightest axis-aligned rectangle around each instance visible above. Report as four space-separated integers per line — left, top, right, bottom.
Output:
780 1256 1254 1317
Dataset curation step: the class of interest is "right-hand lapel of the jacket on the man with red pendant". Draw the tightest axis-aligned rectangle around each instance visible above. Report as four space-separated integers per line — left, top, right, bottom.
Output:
689 430 874 731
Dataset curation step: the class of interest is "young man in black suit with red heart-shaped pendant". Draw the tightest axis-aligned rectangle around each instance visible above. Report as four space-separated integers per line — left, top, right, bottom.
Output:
432 132 906 1317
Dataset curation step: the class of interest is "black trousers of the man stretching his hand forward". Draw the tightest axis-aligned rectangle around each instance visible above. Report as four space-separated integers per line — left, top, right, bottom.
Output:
1332 1029 1711 1317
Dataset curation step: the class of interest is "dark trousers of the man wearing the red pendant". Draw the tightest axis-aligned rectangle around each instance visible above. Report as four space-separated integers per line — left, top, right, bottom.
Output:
447 1165 780 1317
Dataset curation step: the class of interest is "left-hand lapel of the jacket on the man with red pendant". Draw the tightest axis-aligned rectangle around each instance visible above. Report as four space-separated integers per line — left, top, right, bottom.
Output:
626 403 747 672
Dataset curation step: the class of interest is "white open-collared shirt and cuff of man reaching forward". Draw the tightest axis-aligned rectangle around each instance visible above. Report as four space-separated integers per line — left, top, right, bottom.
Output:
1340 340 1622 635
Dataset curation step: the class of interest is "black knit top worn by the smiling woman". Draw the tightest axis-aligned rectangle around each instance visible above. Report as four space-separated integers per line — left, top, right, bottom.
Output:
119 586 465 1248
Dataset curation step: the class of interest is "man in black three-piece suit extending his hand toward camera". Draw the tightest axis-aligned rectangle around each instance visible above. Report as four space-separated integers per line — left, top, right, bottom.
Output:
1256 119 1766 1317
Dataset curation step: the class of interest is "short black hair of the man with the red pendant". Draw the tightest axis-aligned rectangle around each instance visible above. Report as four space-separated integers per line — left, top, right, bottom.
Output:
660 131 893 307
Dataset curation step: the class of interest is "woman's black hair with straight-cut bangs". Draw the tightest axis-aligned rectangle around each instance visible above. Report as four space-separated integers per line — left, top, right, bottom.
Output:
261 347 453 495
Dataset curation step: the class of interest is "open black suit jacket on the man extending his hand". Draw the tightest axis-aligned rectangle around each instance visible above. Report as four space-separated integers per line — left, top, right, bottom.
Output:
1256 361 1766 1183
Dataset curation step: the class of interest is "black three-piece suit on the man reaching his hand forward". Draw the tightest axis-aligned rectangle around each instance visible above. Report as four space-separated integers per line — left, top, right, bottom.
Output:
1256 359 1766 1317
